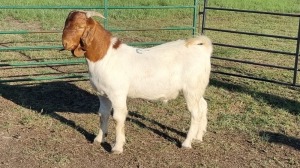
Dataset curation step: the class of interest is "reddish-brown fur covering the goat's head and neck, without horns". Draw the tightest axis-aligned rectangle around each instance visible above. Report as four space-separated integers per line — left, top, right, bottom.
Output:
62 11 116 62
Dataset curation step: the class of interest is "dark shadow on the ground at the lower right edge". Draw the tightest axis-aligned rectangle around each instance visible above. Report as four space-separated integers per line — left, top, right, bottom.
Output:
259 131 300 150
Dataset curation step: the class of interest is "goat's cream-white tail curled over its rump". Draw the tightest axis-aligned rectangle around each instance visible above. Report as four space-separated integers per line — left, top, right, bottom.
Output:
185 35 213 54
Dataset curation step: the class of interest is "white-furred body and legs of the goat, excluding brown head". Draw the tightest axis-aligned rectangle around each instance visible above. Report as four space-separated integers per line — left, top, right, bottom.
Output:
92 36 212 153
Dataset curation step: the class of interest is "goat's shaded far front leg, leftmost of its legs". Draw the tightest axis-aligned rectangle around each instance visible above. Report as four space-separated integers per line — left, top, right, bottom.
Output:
94 96 112 143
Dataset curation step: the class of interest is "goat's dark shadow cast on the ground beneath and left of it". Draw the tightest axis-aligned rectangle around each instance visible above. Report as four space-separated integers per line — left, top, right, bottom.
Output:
0 82 185 151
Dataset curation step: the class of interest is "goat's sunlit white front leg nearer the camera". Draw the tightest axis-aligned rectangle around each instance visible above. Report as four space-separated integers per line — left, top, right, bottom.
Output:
111 98 128 154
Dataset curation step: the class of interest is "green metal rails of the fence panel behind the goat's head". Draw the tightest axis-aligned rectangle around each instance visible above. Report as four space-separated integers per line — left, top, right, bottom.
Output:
0 0 199 83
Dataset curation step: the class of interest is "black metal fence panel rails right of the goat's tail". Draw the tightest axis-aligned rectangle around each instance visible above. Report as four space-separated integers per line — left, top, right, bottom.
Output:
200 0 300 87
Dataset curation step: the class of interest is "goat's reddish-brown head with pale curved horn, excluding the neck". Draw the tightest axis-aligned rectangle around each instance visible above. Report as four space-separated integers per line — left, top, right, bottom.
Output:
62 11 104 57
